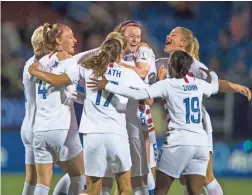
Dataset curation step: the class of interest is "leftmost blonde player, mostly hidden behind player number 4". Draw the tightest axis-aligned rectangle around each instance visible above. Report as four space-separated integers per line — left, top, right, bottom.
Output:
21 26 49 195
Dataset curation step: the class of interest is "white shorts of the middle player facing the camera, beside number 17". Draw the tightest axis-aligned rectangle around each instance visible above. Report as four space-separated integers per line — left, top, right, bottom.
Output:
129 137 149 177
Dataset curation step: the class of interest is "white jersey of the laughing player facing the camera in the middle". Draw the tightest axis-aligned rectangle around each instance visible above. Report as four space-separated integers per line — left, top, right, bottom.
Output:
124 46 156 137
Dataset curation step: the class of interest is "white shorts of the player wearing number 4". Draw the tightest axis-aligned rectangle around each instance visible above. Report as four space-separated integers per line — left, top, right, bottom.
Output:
33 130 82 164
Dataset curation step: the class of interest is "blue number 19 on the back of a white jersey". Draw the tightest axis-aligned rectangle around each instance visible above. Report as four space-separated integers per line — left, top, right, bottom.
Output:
183 97 200 124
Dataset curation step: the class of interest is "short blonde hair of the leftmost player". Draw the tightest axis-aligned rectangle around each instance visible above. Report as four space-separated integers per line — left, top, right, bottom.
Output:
31 26 44 55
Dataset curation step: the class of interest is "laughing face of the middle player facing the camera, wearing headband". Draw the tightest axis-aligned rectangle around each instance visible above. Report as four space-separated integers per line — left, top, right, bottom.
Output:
124 26 141 52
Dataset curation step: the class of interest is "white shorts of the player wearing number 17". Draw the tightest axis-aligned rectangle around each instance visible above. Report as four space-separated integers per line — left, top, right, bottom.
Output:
83 133 132 177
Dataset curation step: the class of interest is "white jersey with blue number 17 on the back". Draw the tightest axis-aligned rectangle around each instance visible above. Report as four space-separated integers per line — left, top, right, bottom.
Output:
79 63 148 137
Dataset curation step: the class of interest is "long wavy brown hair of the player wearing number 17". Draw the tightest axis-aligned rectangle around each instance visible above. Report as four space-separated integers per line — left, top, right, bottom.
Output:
82 32 126 77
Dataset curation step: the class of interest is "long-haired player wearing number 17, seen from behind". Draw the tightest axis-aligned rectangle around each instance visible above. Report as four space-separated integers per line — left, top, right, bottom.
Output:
27 33 153 194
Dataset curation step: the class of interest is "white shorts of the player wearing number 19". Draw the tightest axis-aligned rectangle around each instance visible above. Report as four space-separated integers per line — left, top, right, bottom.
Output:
157 146 209 178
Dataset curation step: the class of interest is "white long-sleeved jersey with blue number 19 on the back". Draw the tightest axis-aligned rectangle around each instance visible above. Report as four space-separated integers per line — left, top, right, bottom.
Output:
106 72 219 146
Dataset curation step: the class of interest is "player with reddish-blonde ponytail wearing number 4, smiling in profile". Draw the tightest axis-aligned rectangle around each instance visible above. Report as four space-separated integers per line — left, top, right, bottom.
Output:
29 24 85 195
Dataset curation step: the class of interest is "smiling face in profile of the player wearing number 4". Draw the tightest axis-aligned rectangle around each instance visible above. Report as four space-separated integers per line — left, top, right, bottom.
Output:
58 26 77 55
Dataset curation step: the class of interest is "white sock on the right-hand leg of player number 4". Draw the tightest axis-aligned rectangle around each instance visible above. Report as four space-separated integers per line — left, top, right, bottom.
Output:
68 175 86 195
